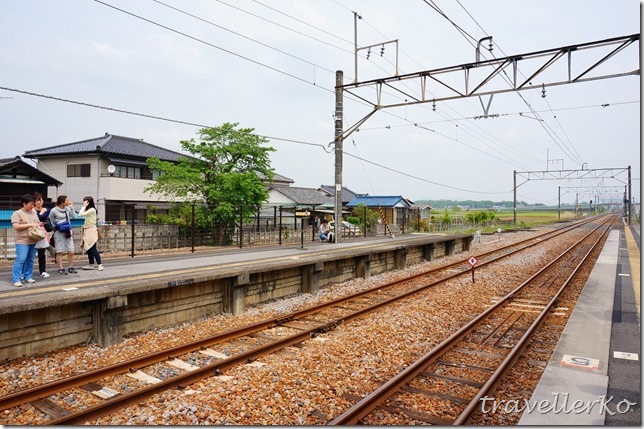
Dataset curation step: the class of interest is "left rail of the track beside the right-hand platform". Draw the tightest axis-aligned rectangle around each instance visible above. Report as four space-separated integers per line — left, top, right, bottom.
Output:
328 217 614 425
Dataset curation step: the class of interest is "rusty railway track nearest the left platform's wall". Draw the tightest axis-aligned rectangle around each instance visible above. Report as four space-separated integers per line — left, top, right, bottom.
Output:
0 216 612 424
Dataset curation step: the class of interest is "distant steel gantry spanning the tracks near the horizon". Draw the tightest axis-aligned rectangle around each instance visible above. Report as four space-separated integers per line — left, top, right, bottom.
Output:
514 165 633 225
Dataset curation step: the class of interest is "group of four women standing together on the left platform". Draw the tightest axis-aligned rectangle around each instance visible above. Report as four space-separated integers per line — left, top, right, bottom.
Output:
11 192 103 287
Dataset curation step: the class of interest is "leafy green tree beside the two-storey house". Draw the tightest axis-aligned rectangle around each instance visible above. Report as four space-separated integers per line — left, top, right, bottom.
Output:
145 123 275 244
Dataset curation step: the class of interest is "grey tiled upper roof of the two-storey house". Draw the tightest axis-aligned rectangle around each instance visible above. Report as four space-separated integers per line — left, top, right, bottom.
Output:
23 133 187 162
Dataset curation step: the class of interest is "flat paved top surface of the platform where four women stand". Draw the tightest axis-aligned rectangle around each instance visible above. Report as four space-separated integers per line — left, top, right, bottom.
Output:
0 234 462 300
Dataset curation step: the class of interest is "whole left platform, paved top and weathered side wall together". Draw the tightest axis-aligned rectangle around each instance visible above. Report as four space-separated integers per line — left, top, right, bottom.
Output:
0 233 473 361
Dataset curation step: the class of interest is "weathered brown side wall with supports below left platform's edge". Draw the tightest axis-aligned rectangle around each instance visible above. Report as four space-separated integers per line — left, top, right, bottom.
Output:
0 232 471 361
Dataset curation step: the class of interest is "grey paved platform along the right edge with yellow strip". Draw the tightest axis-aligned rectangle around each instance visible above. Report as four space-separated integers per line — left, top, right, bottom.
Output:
519 221 641 426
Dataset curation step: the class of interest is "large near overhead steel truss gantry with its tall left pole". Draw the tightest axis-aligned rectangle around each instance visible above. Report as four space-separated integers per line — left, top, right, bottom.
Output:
333 34 640 237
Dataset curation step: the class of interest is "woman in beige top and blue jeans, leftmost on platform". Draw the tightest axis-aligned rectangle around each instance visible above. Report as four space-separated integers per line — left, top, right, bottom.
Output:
11 195 42 287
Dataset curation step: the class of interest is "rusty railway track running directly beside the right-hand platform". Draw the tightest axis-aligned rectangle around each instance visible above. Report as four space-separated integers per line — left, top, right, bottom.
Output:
329 212 614 425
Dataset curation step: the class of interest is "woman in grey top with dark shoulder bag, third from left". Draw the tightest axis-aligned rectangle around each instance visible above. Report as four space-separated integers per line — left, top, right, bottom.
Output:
49 195 78 274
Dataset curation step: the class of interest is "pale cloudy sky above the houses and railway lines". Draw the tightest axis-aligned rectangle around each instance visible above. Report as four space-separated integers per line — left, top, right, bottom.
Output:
0 0 641 205
